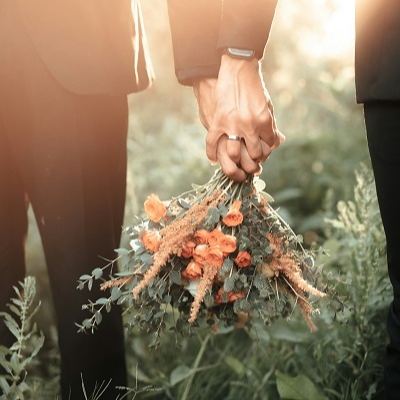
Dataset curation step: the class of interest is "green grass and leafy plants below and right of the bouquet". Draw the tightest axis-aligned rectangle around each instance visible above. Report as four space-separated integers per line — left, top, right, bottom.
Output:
121 163 390 400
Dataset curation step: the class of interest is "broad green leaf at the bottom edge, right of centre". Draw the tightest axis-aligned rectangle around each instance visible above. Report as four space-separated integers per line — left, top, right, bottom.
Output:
275 371 328 400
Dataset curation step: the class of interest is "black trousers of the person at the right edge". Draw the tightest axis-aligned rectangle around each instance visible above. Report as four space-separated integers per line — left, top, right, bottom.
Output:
364 101 400 400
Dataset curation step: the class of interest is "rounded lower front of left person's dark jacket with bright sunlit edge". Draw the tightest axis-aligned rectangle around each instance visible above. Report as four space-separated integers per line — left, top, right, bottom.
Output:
15 0 153 94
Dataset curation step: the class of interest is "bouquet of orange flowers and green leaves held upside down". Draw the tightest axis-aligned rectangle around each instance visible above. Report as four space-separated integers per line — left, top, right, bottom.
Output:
79 169 327 344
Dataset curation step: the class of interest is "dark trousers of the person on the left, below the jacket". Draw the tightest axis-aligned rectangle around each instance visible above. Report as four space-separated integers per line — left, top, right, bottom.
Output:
0 0 128 400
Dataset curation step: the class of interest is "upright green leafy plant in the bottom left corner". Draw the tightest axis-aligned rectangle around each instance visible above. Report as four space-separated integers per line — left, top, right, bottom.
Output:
0 277 44 400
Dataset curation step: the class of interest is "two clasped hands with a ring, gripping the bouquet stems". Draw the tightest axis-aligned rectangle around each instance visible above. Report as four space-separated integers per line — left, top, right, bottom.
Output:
193 55 284 181
